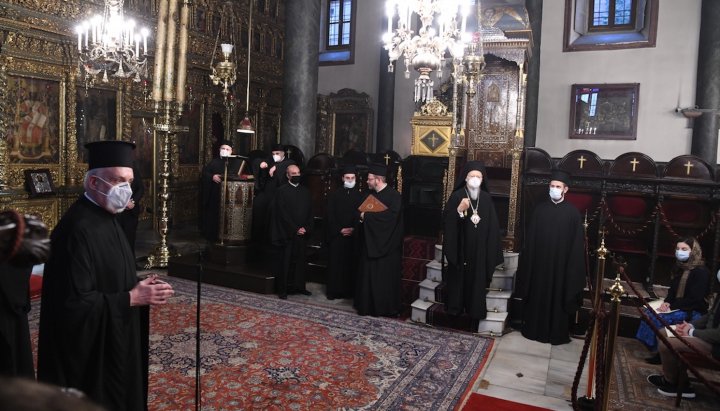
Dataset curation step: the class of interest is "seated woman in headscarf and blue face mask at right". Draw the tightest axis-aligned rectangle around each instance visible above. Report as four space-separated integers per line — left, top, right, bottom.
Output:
635 237 710 364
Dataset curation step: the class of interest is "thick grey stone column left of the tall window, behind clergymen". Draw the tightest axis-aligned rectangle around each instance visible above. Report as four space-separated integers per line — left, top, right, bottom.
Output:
280 0 320 160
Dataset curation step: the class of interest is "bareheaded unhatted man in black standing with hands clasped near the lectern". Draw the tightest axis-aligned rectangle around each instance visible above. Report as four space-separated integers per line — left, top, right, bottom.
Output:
270 164 313 299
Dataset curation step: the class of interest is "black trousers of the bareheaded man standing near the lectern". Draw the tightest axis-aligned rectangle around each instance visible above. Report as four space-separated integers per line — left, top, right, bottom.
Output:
273 236 307 295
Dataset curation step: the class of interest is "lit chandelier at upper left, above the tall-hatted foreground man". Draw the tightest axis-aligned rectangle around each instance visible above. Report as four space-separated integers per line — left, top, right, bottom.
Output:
75 0 150 85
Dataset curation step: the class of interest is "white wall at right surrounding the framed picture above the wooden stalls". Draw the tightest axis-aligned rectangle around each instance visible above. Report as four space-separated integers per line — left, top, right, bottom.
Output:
536 0 701 161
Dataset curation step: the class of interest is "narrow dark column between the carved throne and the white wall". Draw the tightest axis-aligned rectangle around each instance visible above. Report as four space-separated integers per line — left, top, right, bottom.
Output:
524 0 543 147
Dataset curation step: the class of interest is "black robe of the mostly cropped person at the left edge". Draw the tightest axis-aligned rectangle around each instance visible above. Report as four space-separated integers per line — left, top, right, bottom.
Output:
0 263 35 379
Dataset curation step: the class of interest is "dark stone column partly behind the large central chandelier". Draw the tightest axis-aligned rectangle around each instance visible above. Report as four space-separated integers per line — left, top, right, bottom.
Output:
375 17 395 153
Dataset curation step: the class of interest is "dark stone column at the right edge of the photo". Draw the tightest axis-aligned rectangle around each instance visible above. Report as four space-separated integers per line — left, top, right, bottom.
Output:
690 0 720 166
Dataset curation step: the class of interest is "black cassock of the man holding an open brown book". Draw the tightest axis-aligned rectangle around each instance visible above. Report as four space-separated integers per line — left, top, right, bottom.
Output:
355 186 403 316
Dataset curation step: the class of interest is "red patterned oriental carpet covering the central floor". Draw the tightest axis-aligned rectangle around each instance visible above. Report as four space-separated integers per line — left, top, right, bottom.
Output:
141 278 493 410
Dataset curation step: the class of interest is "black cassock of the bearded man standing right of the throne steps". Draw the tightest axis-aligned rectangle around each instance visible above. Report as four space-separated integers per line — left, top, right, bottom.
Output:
515 199 586 344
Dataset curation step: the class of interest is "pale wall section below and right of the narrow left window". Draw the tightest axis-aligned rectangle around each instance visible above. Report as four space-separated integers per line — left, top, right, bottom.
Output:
320 0 385 152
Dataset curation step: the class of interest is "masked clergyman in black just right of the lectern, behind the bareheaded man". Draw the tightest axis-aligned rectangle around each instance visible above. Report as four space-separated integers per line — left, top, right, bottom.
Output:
251 144 295 260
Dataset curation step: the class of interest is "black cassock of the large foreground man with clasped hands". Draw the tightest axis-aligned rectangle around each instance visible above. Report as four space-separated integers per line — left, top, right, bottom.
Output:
38 196 148 411
